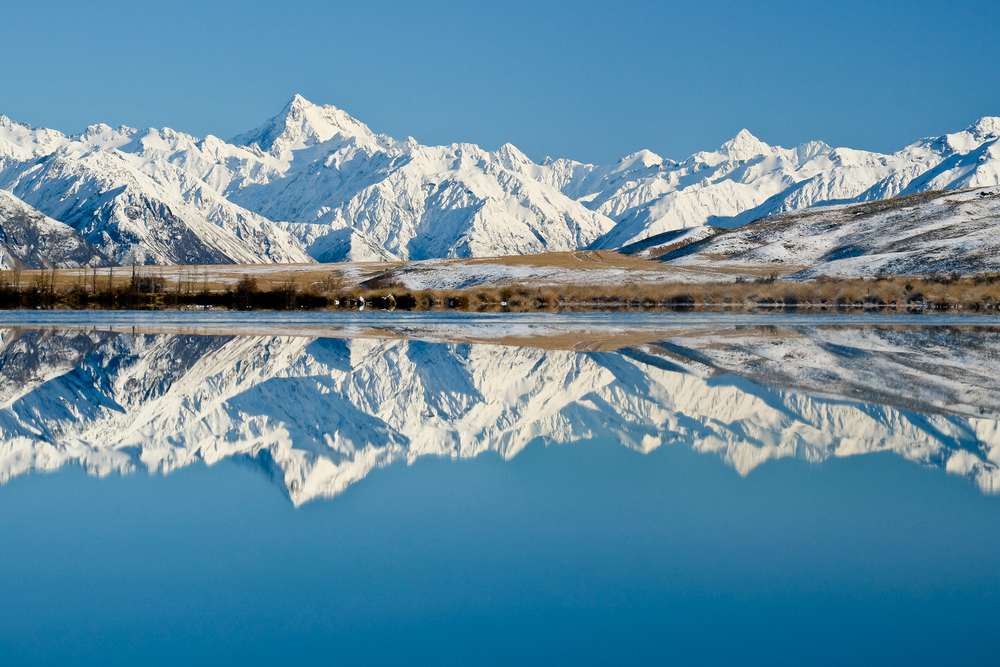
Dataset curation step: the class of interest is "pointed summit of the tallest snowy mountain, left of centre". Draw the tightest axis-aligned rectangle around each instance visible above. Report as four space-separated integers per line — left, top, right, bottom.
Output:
233 93 375 155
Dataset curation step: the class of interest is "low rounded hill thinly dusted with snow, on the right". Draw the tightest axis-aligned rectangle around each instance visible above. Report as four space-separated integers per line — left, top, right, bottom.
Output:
663 187 1000 278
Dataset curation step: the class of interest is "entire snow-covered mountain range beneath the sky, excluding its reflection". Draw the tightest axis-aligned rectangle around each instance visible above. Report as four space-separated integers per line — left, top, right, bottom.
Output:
0 95 1000 267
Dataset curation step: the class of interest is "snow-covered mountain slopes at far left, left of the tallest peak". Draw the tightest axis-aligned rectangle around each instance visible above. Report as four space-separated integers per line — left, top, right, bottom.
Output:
0 118 310 264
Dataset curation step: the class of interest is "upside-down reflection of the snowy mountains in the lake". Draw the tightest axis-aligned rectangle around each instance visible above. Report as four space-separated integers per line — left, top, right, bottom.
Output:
0 325 1000 505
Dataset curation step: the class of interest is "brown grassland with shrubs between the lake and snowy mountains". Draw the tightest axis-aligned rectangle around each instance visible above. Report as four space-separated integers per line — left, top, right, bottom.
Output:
0 260 1000 311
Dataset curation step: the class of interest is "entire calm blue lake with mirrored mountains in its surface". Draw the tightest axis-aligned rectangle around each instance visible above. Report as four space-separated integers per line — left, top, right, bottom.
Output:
0 312 1000 666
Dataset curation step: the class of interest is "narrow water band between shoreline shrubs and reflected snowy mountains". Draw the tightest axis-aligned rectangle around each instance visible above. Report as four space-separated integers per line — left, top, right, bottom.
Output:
0 310 1000 352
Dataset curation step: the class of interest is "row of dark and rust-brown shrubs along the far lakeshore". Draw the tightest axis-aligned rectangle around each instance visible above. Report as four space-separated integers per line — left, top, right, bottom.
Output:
0 272 1000 312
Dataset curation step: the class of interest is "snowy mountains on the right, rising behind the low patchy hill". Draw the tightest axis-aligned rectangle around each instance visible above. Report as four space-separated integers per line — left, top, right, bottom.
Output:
546 117 1000 248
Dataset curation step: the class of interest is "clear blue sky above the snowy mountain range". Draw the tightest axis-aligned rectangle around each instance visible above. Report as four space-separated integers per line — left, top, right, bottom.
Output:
0 0 1000 161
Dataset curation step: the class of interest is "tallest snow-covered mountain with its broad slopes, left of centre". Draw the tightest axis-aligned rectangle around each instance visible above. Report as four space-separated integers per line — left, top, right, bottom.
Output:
226 96 613 261
